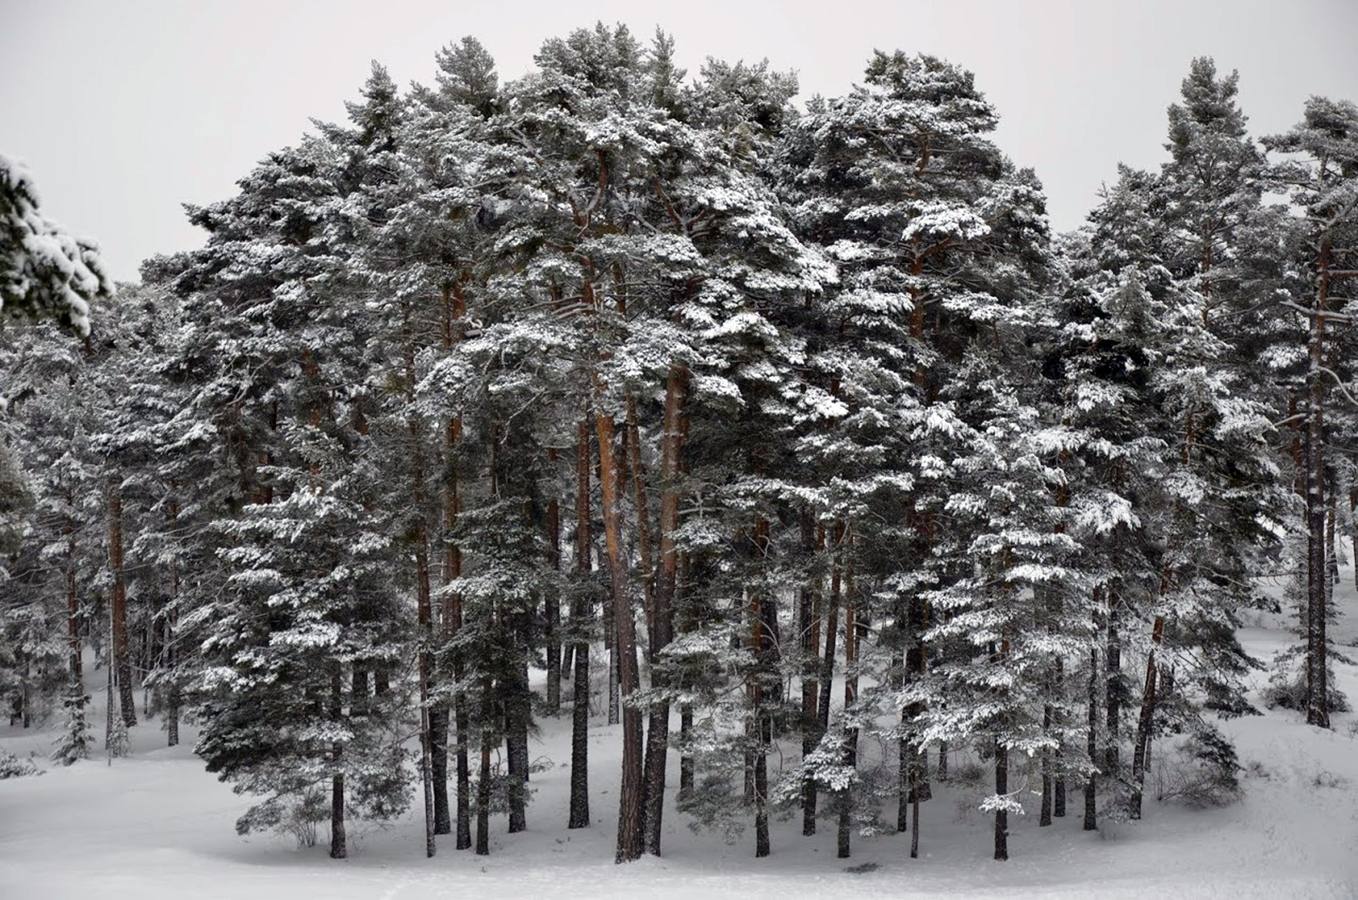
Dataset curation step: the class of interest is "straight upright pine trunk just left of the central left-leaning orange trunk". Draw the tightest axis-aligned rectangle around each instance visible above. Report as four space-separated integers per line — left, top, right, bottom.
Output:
569 421 591 828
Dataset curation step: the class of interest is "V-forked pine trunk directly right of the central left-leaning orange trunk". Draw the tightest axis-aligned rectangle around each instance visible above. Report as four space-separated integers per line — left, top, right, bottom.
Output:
640 362 689 857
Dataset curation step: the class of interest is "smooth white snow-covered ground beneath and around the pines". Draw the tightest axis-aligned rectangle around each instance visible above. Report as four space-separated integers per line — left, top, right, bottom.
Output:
0 570 1358 900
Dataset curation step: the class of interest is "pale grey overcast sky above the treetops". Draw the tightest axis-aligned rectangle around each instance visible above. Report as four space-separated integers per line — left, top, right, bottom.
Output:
0 0 1358 278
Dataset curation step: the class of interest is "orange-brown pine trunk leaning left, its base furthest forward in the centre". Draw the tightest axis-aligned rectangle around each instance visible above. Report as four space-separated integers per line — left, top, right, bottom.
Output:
595 411 642 862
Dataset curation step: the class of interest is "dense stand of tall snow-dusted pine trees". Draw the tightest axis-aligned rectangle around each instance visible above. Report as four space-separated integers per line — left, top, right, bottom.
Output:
0 24 1358 895
